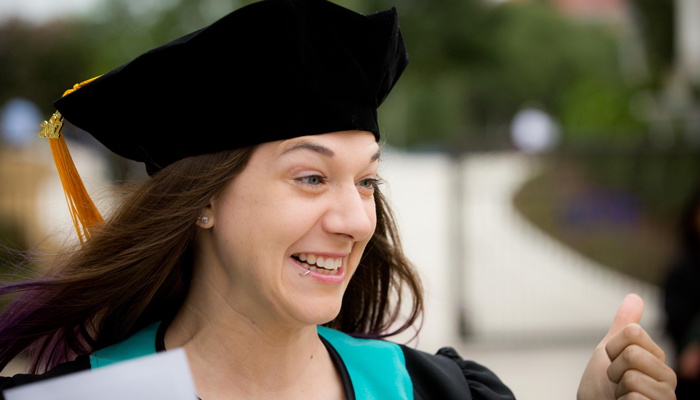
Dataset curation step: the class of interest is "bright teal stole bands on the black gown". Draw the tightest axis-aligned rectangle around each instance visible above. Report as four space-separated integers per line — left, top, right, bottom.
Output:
90 322 413 400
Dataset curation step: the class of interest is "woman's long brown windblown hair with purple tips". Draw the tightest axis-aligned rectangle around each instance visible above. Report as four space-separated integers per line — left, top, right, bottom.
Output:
0 147 423 373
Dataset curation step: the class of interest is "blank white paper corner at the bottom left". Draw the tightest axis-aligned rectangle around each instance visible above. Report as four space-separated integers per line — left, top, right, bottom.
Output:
3 349 197 400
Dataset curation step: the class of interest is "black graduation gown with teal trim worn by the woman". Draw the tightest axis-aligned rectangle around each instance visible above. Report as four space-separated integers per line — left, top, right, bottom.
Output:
0 322 515 400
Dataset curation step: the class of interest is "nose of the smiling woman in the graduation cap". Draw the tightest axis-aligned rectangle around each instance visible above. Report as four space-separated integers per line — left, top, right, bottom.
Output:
323 184 377 241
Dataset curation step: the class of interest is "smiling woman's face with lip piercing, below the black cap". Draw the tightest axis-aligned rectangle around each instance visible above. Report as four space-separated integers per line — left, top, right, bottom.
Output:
200 131 379 325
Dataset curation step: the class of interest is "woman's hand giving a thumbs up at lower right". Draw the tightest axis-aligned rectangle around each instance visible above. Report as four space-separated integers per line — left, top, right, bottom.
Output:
577 294 676 400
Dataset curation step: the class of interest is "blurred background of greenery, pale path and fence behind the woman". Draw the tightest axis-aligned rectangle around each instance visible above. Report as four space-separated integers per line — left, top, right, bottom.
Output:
0 0 700 399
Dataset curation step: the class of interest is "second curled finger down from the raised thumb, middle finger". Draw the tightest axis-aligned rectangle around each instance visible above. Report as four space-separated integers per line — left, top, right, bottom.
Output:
608 345 676 387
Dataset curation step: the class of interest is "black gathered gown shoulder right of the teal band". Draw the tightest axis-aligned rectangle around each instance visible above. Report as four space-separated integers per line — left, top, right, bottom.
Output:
399 345 515 400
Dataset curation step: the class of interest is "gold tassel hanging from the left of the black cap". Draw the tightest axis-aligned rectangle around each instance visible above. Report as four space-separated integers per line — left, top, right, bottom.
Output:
39 77 103 243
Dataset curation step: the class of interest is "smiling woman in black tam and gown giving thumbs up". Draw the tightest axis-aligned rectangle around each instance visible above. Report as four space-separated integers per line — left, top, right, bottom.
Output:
0 0 675 400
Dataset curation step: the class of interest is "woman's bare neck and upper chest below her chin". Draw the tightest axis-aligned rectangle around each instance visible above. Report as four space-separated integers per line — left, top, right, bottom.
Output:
165 264 342 400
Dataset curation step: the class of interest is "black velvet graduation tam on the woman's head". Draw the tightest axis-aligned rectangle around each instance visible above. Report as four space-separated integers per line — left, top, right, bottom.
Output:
54 0 408 173
